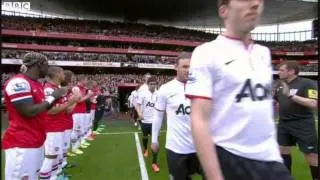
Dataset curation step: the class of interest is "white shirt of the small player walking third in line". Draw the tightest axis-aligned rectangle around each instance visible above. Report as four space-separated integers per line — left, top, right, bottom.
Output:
137 90 157 123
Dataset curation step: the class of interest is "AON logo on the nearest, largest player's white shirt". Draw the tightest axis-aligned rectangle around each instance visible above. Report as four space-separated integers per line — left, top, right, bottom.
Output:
236 79 271 103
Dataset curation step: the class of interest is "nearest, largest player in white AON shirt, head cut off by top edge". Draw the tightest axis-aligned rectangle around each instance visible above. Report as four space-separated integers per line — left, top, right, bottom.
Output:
186 0 292 180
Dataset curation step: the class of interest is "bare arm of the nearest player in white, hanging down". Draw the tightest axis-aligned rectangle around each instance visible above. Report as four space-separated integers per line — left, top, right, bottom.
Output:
191 98 223 180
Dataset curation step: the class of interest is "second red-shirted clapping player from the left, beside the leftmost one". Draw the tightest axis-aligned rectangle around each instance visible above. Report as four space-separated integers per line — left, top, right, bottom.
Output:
40 67 80 180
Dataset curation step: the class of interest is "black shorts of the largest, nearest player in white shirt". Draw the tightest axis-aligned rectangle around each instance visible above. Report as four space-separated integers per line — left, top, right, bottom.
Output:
216 146 293 180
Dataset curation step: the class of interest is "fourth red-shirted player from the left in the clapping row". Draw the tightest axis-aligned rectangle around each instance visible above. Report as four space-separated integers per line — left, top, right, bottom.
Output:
72 77 92 154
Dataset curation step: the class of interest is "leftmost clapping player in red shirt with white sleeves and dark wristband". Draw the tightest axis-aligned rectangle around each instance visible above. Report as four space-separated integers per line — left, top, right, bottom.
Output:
2 52 66 180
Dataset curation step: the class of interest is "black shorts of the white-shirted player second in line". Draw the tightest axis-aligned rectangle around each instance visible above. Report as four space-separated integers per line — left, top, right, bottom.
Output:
167 149 205 180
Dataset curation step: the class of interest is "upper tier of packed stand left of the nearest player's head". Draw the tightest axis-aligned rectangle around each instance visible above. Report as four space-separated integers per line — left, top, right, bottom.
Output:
2 16 216 41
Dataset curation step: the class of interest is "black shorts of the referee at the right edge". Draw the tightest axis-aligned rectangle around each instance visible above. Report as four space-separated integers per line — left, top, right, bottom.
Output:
277 120 318 153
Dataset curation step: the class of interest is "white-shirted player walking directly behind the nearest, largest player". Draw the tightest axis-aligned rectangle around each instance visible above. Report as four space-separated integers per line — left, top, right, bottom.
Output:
151 53 203 180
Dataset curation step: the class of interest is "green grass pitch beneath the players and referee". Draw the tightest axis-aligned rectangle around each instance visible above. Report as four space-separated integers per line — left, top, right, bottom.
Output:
1 117 311 180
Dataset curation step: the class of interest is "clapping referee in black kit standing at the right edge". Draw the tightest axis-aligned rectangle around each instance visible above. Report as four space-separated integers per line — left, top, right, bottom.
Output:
275 61 319 180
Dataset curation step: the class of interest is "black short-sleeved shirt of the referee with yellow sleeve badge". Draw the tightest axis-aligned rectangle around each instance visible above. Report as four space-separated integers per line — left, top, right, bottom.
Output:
275 77 318 121
